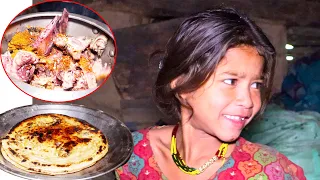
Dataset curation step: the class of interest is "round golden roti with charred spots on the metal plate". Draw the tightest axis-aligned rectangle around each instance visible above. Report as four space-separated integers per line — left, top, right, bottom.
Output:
1 114 108 175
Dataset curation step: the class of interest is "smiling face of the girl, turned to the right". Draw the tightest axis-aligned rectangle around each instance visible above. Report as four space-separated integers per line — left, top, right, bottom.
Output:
181 46 264 142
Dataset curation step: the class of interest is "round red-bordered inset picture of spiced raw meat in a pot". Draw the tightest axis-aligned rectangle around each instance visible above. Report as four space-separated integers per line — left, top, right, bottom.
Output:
1 1 116 102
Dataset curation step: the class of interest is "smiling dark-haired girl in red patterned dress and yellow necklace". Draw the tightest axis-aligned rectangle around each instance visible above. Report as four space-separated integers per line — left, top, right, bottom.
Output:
116 9 305 180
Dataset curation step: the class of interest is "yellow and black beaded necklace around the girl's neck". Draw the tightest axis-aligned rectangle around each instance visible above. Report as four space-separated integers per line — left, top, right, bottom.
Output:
171 124 228 175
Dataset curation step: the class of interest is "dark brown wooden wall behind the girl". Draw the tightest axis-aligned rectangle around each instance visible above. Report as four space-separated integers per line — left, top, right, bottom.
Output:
34 0 320 130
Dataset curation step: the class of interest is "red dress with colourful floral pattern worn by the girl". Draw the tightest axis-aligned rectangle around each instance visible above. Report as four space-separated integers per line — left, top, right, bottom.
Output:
116 129 306 180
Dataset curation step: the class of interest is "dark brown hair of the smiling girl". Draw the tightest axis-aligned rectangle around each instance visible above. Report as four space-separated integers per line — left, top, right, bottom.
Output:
154 9 276 120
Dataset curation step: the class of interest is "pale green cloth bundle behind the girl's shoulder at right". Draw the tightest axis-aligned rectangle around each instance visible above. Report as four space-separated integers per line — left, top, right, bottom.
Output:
241 104 320 180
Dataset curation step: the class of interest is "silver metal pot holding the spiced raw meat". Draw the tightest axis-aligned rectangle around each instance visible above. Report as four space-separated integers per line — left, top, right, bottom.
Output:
1 12 115 102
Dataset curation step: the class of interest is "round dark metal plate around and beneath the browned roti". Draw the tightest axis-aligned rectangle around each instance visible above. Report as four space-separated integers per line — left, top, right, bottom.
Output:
0 104 133 180
